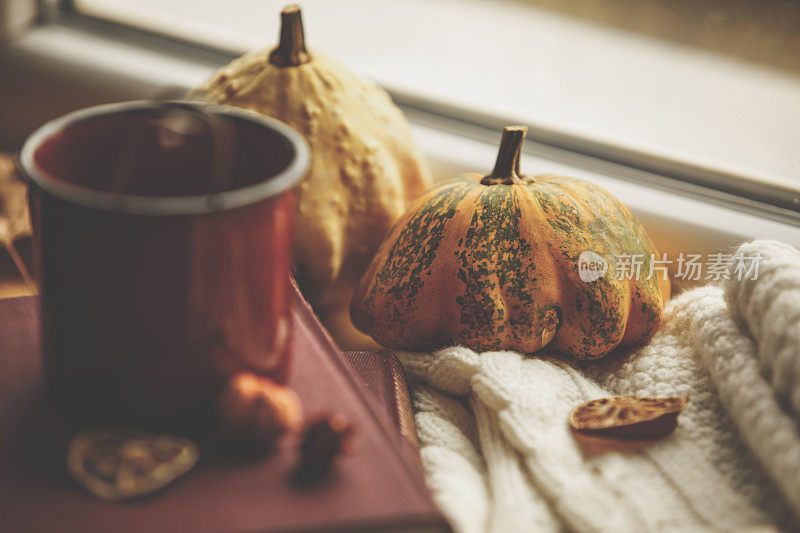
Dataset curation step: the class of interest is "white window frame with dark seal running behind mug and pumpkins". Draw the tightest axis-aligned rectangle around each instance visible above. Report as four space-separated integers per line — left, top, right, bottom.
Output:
0 0 800 262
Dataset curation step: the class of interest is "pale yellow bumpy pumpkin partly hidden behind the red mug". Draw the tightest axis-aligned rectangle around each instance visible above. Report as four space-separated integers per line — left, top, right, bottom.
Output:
189 6 431 305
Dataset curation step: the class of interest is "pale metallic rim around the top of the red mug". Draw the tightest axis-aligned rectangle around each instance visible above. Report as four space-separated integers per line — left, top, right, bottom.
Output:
19 100 311 215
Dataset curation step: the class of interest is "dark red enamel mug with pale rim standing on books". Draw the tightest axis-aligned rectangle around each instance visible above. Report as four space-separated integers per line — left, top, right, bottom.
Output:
20 101 310 430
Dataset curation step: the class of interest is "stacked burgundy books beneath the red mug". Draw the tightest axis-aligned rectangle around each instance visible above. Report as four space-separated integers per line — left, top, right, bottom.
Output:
0 288 449 533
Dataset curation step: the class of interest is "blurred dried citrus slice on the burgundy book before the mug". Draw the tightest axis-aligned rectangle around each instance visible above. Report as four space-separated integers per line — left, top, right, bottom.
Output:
67 429 200 501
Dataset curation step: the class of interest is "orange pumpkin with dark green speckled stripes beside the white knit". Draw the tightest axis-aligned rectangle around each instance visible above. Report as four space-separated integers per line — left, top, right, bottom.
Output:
350 127 669 359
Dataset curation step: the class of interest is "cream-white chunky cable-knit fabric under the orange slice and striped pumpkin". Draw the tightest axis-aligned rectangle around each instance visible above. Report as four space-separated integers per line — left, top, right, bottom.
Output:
400 241 800 532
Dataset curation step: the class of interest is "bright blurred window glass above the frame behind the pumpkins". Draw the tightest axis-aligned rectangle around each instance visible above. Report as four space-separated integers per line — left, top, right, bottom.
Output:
59 0 800 194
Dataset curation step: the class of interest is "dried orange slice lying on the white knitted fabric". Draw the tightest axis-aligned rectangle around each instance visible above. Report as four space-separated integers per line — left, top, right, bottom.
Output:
569 396 689 440
